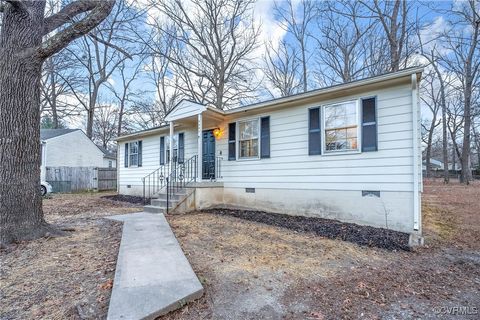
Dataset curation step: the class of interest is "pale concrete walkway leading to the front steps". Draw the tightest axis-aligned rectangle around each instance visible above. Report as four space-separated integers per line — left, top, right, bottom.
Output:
107 212 203 320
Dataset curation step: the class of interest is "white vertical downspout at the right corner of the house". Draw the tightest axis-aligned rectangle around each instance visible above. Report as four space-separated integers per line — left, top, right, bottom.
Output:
412 73 420 231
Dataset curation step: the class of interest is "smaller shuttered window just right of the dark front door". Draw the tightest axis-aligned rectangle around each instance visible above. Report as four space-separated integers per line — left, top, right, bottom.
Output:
238 119 260 158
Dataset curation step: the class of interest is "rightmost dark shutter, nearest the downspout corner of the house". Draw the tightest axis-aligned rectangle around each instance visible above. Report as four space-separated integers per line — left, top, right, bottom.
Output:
362 98 378 152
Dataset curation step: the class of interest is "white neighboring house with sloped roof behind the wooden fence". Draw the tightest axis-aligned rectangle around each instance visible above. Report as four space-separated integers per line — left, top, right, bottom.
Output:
40 129 117 180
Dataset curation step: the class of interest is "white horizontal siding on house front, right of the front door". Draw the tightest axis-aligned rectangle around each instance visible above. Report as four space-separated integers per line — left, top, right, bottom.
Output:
217 84 413 191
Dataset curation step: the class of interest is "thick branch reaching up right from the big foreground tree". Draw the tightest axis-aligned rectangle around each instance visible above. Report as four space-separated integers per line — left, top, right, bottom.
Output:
33 0 115 59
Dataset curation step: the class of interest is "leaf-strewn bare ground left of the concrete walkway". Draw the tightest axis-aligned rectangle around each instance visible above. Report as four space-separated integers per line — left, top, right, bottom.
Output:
0 193 139 319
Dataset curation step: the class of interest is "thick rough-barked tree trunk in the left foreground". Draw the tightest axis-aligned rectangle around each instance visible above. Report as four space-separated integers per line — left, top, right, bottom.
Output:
0 1 58 244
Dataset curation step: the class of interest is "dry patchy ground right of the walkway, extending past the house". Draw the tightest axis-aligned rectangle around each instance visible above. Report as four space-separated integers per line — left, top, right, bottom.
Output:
162 181 480 319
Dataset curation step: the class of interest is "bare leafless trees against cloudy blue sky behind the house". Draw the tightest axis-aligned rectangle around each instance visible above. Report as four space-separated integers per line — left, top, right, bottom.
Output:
35 0 480 183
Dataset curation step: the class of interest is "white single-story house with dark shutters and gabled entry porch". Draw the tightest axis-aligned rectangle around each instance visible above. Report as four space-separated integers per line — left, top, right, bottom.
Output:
117 68 423 235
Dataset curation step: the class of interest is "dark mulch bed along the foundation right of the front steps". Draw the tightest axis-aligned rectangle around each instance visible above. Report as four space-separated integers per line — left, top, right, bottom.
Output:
202 208 410 251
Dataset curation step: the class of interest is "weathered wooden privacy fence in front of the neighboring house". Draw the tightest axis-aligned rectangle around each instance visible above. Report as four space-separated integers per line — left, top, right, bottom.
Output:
45 167 117 192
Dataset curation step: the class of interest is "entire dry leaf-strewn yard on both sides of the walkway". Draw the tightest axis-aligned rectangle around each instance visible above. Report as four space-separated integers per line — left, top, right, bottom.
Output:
0 181 480 320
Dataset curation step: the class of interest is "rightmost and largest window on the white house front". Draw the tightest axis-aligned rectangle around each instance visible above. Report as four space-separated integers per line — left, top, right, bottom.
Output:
323 101 359 152
